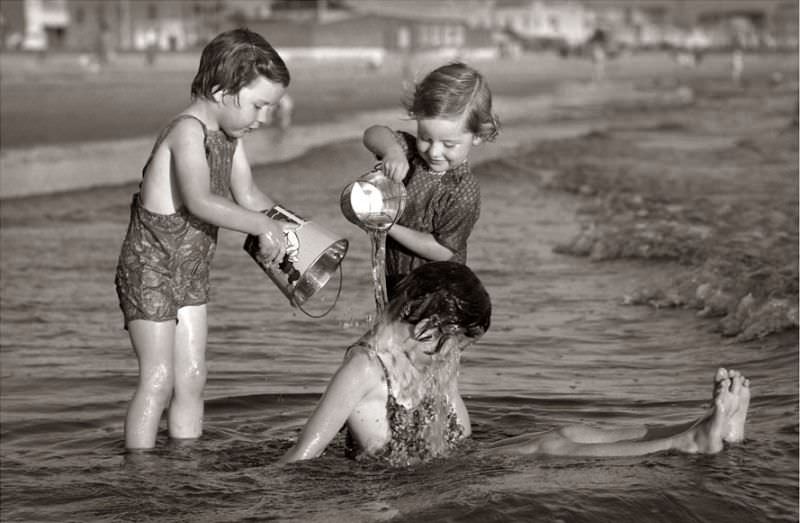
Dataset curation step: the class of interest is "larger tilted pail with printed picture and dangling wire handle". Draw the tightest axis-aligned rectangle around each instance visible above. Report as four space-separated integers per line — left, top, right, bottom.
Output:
244 205 348 318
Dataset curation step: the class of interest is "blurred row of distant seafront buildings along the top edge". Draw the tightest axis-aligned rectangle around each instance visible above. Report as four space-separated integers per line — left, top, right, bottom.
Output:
0 0 798 52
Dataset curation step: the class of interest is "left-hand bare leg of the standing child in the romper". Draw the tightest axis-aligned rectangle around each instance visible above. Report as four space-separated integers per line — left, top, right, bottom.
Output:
125 320 175 449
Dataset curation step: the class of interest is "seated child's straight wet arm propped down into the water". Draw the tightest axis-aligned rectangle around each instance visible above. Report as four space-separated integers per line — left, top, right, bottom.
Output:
280 351 383 463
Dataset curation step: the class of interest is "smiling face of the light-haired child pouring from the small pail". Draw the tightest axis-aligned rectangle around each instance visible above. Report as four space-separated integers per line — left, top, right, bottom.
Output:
417 118 480 172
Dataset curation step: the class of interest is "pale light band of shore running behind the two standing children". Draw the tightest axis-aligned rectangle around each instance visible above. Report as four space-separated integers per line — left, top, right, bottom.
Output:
0 82 682 198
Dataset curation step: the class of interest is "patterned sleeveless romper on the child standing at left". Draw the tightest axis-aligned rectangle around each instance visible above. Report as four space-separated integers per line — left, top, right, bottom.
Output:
115 115 237 328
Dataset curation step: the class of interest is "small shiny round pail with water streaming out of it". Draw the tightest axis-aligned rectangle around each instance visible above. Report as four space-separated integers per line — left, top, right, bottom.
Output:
339 169 408 231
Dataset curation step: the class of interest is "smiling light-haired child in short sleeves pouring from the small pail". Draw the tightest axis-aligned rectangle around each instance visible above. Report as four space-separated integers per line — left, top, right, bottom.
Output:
364 62 499 298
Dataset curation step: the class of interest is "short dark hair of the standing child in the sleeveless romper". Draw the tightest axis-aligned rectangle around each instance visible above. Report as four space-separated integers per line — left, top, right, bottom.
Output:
192 28 290 99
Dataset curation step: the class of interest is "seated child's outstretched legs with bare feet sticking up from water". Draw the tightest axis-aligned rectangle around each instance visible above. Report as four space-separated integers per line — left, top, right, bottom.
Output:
492 369 750 456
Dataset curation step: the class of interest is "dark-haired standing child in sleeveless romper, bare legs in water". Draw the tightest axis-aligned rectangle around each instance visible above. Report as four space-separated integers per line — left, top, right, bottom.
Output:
115 29 290 449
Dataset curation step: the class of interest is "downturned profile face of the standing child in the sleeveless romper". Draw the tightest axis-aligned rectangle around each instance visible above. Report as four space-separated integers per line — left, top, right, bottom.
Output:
214 76 286 138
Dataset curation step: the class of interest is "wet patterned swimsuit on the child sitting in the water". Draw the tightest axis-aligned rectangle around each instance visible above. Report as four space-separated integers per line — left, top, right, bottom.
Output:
345 347 464 466
